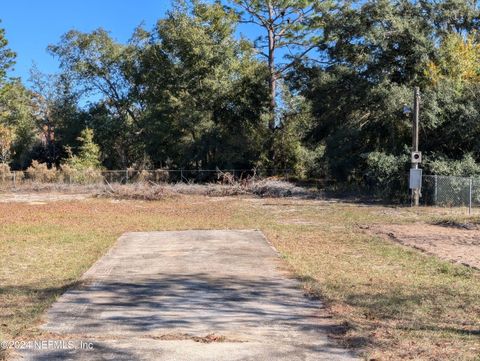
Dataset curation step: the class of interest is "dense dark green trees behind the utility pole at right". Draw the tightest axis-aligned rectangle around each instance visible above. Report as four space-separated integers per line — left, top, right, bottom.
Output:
291 0 480 189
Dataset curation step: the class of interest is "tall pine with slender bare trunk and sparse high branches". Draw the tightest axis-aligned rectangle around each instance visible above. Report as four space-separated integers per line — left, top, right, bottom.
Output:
230 0 329 131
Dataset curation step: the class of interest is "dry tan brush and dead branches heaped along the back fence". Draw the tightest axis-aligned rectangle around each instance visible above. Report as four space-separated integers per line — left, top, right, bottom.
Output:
0 169 323 201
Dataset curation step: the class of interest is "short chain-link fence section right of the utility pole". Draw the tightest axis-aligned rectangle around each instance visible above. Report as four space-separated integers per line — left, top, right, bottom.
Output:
421 175 480 210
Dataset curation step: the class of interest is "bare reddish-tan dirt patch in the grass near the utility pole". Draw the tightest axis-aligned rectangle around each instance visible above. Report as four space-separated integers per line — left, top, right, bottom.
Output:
368 223 480 269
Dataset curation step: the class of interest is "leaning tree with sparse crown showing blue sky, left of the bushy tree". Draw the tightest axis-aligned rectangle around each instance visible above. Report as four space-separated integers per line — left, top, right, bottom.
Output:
49 29 144 167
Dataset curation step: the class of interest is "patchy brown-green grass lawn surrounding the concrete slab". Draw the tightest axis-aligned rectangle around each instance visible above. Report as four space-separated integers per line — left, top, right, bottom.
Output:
0 196 480 360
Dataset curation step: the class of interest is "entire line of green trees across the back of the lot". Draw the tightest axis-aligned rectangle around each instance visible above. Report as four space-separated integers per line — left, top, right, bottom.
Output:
0 0 480 197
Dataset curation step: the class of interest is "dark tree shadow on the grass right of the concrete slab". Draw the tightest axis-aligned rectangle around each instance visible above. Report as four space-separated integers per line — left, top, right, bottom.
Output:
298 276 480 348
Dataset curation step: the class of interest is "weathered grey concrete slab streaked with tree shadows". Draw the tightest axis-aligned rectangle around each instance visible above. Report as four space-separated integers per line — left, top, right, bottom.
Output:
14 230 355 361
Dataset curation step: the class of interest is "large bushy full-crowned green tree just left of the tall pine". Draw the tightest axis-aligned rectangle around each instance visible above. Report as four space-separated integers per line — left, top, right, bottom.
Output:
137 1 267 168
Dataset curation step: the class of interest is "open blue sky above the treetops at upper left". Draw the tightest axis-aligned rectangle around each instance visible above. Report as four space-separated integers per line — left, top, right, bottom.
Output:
0 0 170 81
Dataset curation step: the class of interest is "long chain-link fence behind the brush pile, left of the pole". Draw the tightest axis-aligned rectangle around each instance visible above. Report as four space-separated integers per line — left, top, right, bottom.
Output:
0 167 292 190
